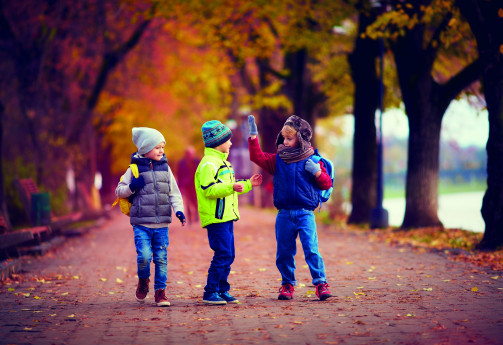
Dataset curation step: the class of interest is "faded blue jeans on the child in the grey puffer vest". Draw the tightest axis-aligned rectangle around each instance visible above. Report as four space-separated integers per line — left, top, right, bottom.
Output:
133 225 169 290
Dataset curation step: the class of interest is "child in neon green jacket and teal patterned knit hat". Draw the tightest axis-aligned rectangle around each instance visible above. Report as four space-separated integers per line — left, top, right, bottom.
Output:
195 120 262 304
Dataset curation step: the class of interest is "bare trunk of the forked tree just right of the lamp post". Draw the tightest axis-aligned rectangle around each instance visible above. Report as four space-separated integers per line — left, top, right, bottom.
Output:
393 26 448 229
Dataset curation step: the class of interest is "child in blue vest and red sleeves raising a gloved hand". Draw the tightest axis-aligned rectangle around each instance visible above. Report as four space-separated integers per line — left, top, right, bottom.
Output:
248 115 332 301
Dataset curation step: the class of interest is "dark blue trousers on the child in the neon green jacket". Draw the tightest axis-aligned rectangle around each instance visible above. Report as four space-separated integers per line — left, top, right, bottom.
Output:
204 221 236 293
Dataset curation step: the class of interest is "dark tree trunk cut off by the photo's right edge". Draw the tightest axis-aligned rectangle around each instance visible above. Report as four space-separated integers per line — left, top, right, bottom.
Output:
457 0 503 249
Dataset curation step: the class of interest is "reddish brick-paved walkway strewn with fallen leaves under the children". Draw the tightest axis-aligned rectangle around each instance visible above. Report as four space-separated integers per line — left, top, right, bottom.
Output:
0 207 503 345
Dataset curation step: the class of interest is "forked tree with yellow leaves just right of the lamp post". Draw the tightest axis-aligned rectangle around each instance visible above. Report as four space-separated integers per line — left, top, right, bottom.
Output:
370 0 482 228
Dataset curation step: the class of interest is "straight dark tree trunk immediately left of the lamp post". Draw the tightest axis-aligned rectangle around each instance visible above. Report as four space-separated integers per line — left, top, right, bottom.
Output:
348 13 379 224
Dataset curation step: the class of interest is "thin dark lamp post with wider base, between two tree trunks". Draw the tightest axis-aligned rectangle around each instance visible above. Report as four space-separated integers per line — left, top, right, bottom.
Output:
370 1 388 229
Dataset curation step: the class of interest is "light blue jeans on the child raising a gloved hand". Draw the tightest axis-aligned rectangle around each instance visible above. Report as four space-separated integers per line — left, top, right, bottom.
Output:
276 209 327 285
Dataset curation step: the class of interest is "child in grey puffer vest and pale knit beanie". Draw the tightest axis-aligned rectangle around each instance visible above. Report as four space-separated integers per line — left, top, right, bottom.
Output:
115 127 186 307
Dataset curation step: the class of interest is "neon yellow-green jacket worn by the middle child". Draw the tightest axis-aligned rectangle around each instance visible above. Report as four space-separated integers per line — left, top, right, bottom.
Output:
194 147 252 228
